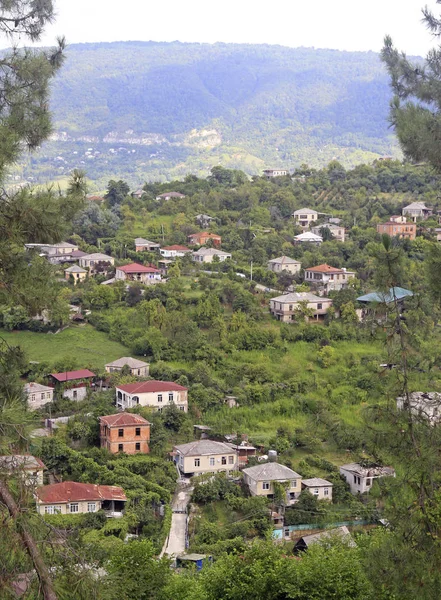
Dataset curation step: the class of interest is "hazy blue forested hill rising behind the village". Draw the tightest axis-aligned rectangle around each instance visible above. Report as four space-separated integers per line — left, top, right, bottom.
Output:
16 42 398 183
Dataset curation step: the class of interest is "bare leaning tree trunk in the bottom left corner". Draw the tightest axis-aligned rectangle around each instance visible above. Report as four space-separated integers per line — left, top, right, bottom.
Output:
0 480 58 600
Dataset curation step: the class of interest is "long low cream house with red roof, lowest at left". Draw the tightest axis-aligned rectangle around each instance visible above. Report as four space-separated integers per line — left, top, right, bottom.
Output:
35 481 127 517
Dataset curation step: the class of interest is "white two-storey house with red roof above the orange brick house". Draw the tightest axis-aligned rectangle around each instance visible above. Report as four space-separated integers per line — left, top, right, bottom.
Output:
115 380 188 412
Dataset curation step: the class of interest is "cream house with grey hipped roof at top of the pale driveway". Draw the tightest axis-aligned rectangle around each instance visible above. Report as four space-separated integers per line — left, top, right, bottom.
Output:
173 439 237 476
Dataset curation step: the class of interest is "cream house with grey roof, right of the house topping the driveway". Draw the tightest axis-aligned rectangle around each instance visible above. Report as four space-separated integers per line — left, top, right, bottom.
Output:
242 462 302 504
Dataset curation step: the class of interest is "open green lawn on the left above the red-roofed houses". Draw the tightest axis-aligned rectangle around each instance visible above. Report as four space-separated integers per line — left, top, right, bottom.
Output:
0 325 129 370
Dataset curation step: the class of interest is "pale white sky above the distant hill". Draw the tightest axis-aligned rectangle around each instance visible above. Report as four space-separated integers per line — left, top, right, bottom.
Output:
27 0 441 54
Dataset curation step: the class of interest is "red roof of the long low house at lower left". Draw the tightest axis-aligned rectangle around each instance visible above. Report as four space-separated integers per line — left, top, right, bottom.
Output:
36 481 127 504
